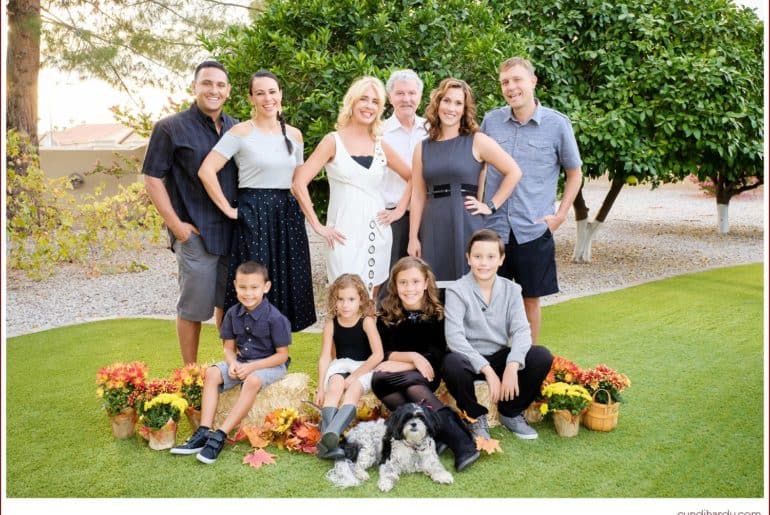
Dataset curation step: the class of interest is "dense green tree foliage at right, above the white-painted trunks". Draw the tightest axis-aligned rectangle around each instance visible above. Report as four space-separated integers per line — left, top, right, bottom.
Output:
492 0 764 238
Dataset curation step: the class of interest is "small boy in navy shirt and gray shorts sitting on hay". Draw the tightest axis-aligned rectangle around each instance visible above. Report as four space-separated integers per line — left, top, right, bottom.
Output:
171 261 291 464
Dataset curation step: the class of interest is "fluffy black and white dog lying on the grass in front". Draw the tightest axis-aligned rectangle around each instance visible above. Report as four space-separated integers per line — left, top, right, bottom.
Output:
326 404 454 492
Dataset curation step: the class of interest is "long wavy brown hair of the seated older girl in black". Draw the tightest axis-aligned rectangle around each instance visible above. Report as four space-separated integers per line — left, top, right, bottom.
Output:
380 256 444 325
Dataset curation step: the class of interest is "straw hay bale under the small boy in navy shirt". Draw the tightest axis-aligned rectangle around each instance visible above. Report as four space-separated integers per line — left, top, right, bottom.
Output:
214 373 310 427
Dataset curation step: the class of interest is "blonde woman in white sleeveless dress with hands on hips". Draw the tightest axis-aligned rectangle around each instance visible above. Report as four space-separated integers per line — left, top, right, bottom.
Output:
292 77 411 298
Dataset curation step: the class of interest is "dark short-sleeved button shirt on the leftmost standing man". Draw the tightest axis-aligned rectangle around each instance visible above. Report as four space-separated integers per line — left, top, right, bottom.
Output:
142 103 238 256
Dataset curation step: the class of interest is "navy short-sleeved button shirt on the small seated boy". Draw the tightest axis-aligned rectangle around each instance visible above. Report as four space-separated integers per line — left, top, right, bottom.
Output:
219 297 291 365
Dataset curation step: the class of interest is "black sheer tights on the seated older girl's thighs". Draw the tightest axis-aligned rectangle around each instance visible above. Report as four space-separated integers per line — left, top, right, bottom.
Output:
372 370 444 411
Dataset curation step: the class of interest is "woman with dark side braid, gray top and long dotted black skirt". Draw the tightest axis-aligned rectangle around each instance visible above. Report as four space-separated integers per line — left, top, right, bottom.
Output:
198 70 316 332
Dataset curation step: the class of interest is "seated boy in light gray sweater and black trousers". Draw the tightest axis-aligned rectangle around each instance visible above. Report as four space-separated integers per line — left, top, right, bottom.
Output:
442 229 553 440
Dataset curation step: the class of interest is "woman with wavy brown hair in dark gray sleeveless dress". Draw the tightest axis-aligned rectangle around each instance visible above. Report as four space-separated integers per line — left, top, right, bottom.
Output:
408 77 521 281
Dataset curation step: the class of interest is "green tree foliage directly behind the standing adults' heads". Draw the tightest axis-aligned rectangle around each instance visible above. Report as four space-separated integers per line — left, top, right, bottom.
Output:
204 0 524 216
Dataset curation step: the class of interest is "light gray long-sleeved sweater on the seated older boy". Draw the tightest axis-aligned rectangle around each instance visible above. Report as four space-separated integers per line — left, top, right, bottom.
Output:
444 272 532 373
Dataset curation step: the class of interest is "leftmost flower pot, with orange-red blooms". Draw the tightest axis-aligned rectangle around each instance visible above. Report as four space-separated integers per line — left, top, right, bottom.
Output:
96 361 147 438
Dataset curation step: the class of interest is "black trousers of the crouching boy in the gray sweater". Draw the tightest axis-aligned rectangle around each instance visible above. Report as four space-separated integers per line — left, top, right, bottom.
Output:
441 345 553 418
